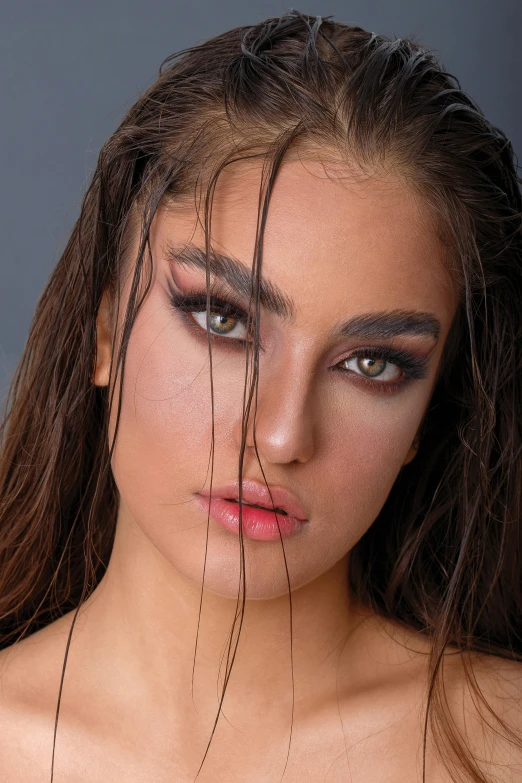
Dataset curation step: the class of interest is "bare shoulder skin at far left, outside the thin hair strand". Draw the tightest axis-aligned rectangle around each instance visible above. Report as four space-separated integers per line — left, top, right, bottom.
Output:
0 616 75 783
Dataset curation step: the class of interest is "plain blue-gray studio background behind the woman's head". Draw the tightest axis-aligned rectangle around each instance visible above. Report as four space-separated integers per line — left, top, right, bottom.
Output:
0 0 522 400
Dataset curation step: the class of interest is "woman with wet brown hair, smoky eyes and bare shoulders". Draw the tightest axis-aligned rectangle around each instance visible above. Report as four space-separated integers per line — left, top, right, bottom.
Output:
0 11 522 783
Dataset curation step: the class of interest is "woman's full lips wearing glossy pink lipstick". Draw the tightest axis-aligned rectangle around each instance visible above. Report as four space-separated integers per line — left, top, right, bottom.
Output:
195 479 308 541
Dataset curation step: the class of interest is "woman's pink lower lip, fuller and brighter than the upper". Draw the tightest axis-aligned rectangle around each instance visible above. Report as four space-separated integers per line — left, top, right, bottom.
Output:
196 495 308 541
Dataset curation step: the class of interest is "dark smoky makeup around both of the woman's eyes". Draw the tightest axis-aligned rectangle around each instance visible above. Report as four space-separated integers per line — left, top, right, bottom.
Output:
168 280 430 394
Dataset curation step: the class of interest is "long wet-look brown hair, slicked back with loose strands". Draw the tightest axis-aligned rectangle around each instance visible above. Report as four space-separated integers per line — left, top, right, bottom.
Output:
0 10 522 783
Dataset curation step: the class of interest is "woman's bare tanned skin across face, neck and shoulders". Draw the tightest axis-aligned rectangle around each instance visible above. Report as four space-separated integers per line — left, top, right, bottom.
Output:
0 156 522 783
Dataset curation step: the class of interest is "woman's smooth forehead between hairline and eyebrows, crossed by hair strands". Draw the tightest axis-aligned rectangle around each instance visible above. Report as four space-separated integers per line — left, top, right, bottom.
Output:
155 160 455 324
